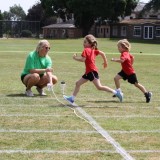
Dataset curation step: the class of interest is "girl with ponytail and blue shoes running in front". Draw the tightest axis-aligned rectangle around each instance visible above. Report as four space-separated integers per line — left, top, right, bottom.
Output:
64 34 123 104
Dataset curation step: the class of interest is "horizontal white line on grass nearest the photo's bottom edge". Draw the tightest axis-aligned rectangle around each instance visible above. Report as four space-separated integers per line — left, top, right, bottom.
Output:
0 149 160 154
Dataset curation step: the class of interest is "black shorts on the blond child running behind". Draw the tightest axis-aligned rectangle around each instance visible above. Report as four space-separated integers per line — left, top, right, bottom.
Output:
118 70 138 84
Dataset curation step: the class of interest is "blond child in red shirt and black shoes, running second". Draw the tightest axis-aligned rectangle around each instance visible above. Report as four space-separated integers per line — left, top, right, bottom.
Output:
111 39 152 103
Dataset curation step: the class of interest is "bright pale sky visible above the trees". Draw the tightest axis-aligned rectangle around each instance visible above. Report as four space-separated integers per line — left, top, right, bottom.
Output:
0 0 149 14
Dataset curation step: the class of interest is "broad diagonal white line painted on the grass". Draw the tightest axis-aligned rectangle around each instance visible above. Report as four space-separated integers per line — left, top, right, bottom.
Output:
76 107 134 160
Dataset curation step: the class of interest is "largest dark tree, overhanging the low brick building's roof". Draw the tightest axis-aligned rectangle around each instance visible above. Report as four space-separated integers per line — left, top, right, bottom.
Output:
40 0 138 35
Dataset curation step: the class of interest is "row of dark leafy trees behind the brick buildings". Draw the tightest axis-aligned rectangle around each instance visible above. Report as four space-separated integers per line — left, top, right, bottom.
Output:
0 0 160 35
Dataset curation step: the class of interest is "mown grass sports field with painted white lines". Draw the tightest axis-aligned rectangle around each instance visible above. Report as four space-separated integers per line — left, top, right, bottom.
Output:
0 39 160 160
